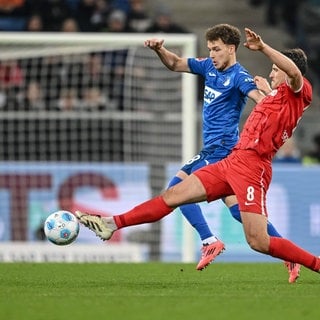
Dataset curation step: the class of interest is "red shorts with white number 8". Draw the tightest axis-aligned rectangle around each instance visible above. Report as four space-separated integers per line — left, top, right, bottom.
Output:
194 150 272 216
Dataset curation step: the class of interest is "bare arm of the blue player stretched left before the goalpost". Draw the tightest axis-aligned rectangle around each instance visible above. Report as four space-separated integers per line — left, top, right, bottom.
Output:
144 39 190 72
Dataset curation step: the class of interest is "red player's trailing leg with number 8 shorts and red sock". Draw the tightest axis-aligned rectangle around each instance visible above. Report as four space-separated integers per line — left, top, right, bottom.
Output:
228 153 320 271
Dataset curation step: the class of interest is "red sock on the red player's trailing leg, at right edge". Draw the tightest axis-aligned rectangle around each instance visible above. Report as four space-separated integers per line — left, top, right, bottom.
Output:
269 237 320 271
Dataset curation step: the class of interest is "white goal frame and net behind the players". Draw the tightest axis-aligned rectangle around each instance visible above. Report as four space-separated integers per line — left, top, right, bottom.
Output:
0 33 197 261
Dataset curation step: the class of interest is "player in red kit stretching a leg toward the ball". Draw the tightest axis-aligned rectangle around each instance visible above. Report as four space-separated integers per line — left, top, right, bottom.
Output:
76 28 320 272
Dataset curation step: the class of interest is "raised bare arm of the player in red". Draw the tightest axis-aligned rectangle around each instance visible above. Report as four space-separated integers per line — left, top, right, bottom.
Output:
244 28 303 91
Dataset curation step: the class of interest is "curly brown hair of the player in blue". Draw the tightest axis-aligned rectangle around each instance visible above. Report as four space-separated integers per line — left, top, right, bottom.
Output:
206 23 241 50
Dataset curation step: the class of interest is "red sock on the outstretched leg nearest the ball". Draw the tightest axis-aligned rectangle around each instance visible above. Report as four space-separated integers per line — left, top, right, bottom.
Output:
113 196 174 229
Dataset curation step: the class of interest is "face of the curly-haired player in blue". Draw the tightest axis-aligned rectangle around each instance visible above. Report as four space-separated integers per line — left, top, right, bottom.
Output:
207 39 235 71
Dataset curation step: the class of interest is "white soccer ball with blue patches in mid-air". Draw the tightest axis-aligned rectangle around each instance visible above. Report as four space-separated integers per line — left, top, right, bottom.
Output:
44 210 80 246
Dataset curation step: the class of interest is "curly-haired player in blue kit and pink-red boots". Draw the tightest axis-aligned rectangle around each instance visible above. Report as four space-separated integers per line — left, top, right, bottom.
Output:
145 24 300 282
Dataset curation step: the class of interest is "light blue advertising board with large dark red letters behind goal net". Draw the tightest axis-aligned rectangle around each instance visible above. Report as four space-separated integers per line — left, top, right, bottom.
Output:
0 162 150 242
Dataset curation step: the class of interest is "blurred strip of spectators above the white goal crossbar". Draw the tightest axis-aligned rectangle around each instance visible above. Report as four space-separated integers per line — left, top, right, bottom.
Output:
0 0 188 33
